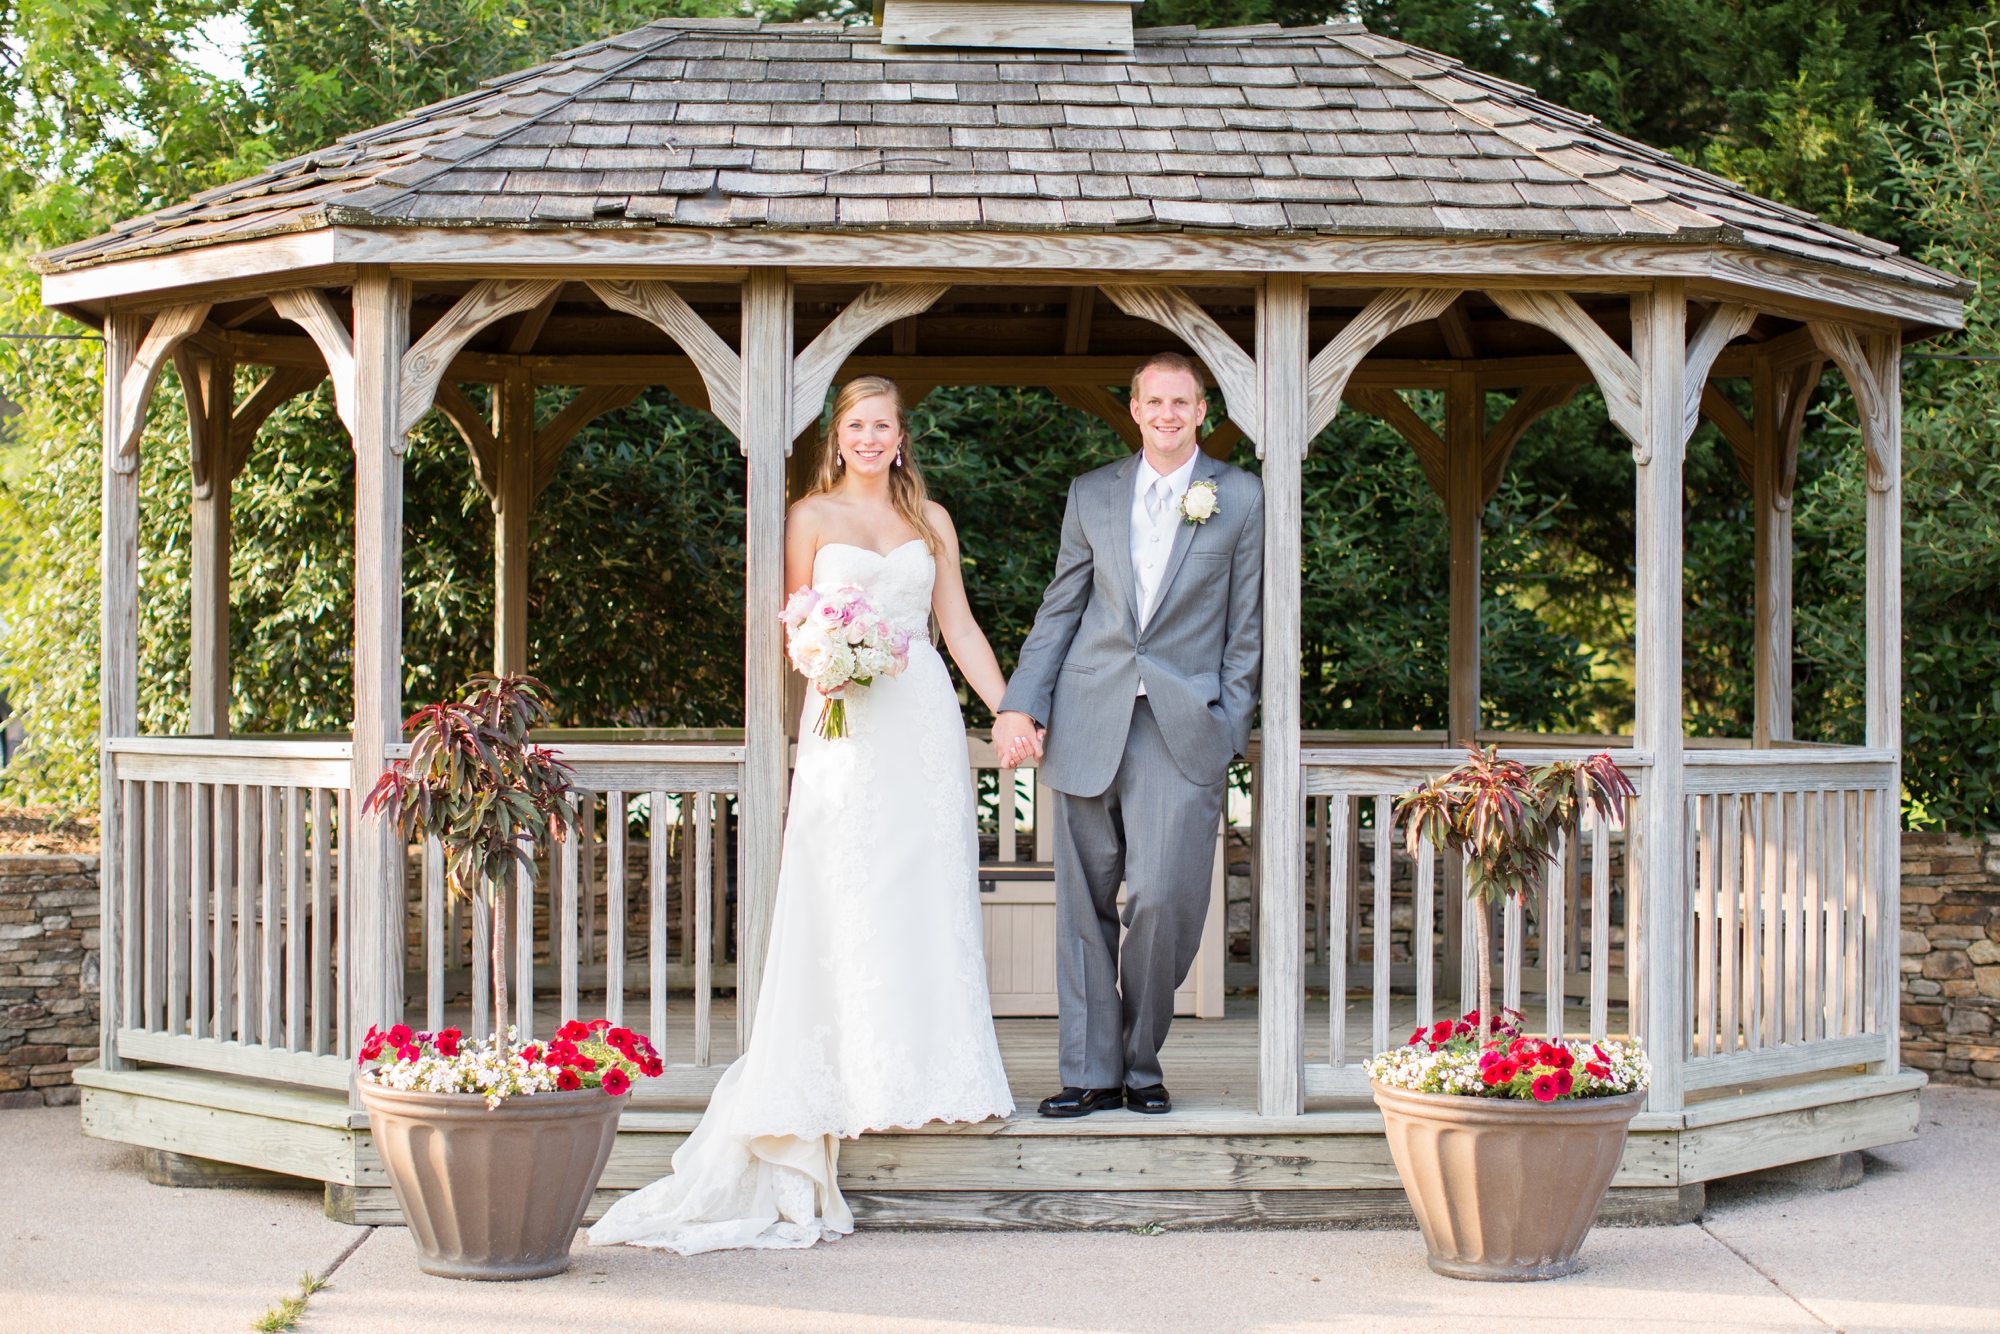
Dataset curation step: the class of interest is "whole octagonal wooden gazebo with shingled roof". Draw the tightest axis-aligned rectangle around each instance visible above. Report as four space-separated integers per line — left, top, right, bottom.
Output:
36 0 1964 1226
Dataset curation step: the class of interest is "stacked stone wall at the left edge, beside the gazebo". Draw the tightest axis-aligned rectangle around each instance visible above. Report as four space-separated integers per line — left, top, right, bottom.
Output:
0 856 98 1108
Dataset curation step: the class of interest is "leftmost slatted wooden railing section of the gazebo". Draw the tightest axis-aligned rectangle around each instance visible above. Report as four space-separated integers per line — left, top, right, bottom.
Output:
102 736 354 1088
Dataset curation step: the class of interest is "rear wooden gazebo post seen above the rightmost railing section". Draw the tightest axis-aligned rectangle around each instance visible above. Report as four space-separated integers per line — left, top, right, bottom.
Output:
1750 356 1792 750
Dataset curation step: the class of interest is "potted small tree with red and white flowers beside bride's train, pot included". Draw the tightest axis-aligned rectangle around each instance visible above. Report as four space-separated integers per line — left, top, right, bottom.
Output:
358 676 660 1278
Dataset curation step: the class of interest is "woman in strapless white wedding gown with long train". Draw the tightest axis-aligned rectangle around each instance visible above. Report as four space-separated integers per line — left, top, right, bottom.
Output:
590 376 1014 1256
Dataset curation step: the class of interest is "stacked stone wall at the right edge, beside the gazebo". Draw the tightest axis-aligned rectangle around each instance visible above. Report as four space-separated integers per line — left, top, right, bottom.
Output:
1902 834 2000 1088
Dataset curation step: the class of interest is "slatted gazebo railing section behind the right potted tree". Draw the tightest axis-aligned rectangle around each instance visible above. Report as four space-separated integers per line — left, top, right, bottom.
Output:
1300 746 1652 1098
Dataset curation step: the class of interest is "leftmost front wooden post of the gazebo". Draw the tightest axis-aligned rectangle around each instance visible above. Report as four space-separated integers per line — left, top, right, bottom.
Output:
98 314 140 1070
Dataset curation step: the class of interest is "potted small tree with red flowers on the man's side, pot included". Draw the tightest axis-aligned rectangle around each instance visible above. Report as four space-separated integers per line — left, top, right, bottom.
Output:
1368 746 1650 1282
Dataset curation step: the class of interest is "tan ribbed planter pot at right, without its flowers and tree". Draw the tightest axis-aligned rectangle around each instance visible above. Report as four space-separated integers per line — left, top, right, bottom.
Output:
1374 1084 1646 1282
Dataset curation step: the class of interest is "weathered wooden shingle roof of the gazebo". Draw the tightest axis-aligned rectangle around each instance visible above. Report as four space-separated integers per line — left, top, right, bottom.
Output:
36 20 1960 292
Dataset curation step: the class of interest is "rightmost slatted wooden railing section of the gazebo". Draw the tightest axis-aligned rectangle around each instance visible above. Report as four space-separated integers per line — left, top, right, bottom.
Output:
1682 748 1900 1090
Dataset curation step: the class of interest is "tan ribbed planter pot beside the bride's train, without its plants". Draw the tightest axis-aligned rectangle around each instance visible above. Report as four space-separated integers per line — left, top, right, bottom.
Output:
360 1080 632 1278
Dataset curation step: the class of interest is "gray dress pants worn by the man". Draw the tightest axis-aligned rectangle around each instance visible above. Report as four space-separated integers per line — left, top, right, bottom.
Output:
1054 696 1228 1088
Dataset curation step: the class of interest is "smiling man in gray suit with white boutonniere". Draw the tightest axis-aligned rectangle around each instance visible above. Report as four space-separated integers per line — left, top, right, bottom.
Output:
994 352 1264 1116
